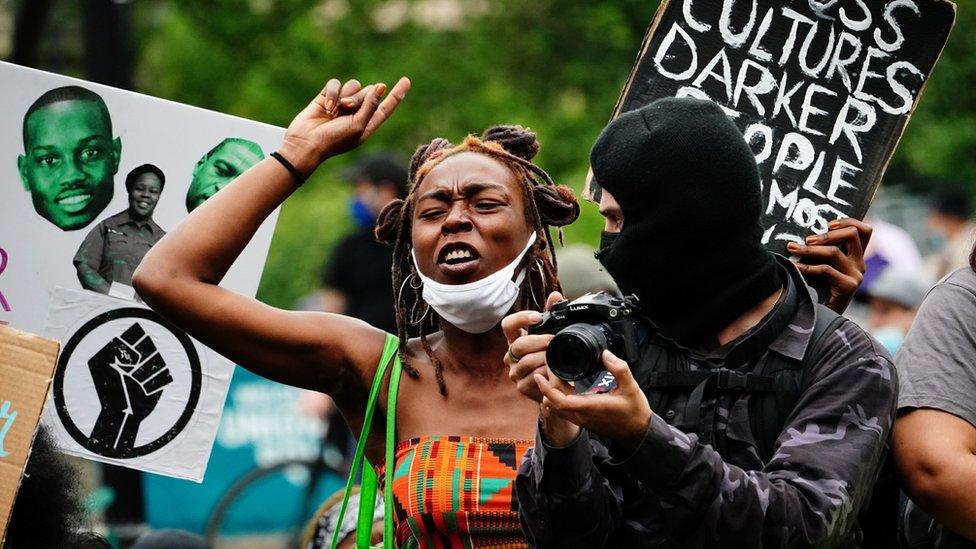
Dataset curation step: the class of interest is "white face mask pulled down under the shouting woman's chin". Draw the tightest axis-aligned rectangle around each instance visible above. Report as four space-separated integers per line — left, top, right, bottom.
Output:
410 232 536 334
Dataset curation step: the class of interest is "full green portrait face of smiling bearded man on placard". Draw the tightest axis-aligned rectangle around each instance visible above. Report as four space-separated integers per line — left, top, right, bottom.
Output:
17 86 122 231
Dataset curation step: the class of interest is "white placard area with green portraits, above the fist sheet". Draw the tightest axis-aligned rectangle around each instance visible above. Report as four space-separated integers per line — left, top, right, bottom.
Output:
0 63 284 332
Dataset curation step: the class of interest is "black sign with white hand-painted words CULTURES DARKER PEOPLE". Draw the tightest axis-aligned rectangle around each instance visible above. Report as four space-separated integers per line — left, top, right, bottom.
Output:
588 0 955 252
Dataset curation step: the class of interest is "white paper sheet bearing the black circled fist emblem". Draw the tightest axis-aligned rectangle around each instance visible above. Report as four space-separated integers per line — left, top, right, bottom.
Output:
44 288 234 482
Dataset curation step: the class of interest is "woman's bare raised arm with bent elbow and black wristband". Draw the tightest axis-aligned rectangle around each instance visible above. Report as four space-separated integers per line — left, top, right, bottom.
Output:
132 78 410 394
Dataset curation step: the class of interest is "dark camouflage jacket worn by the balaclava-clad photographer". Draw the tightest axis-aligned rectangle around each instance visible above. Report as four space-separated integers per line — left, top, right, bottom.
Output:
516 263 897 548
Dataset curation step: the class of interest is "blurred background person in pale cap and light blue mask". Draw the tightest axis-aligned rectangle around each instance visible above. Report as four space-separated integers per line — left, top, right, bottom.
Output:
867 269 928 356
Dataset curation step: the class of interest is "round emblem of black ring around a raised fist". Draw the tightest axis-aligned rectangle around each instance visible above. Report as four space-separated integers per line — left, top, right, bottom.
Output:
53 307 202 459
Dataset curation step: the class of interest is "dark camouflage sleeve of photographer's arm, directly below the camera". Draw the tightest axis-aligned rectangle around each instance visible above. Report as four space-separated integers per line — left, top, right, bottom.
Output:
515 429 622 548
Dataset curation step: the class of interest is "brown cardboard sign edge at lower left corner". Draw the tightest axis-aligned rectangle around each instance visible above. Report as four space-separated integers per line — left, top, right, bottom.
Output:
0 326 58 545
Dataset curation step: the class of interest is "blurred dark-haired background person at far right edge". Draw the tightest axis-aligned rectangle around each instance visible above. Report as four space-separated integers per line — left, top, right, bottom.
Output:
925 189 976 283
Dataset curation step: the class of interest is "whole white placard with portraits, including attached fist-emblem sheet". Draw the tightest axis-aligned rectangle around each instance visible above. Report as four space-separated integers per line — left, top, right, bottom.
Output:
0 63 284 481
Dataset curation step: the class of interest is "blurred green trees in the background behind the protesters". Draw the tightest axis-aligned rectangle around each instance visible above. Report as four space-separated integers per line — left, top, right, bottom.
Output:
38 0 976 307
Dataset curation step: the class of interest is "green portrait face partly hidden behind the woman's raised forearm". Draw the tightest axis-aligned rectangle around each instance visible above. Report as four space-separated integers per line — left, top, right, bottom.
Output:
186 137 264 212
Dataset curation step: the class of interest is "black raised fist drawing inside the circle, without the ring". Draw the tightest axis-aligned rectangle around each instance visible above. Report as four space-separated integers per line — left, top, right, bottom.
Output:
88 323 173 457
